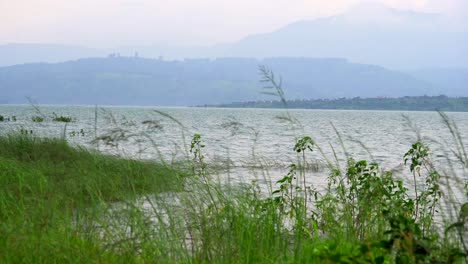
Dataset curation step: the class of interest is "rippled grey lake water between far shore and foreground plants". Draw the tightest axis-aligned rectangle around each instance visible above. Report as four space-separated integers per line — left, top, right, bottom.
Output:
0 105 468 190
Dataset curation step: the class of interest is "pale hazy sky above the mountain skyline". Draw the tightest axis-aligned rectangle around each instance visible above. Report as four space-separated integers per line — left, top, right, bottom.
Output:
0 0 468 47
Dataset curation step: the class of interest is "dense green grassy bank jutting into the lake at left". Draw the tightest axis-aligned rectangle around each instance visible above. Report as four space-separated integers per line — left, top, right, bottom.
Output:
0 135 186 263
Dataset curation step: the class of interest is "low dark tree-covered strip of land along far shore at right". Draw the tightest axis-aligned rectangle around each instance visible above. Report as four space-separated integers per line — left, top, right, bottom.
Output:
205 95 468 112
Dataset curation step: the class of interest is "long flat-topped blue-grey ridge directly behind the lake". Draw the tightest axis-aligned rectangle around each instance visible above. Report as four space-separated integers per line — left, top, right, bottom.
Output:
0 56 444 106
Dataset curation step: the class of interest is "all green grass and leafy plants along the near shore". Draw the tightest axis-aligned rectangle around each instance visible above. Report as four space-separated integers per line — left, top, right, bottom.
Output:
0 134 467 263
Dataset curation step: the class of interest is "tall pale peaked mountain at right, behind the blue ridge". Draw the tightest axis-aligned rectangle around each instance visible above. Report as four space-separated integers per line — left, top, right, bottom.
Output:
221 4 468 69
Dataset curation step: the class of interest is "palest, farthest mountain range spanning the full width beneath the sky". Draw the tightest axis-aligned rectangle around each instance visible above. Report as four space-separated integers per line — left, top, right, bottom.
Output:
0 0 468 70
